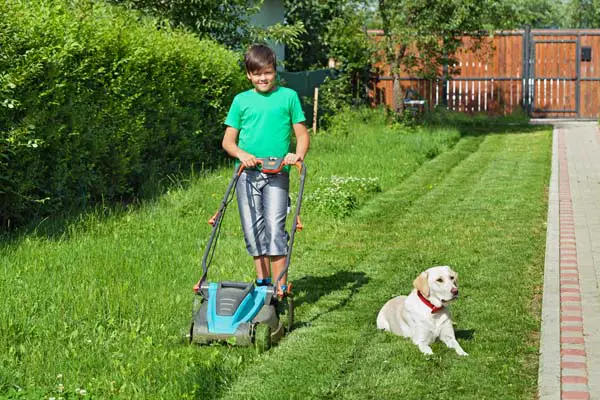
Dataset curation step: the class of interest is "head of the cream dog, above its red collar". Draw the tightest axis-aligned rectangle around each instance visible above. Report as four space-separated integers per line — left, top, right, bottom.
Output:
413 266 458 303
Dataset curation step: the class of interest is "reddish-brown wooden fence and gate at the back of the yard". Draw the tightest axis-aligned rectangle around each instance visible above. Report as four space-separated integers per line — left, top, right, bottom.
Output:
372 29 600 119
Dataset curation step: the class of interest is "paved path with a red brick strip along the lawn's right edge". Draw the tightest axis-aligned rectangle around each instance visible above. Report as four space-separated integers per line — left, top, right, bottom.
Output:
539 121 600 400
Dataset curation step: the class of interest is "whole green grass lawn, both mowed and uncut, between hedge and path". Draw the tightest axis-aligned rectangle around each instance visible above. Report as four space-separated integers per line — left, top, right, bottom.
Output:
0 109 551 399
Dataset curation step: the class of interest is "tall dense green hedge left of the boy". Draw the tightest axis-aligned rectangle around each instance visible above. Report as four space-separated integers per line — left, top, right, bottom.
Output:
0 0 245 229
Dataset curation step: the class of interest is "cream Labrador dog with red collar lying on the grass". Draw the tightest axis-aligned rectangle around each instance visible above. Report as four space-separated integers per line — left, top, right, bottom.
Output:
377 266 468 356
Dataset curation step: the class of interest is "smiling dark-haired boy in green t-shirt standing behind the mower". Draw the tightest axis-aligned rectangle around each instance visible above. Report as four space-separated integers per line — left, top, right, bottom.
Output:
223 44 310 296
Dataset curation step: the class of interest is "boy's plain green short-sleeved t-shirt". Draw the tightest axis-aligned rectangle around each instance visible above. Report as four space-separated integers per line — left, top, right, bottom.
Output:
225 87 306 158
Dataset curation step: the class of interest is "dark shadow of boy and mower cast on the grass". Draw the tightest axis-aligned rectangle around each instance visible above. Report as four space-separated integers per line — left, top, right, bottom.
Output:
294 271 369 328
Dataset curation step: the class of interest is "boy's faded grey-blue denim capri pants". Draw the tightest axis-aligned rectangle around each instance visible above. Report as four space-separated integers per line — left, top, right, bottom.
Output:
236 169 290 257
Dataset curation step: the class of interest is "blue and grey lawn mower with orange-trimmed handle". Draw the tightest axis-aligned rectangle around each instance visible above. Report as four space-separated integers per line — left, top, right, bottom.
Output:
188 157 306 352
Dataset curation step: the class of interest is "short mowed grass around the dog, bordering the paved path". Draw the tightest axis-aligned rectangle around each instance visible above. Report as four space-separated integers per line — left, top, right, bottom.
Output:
219 130 549 398
